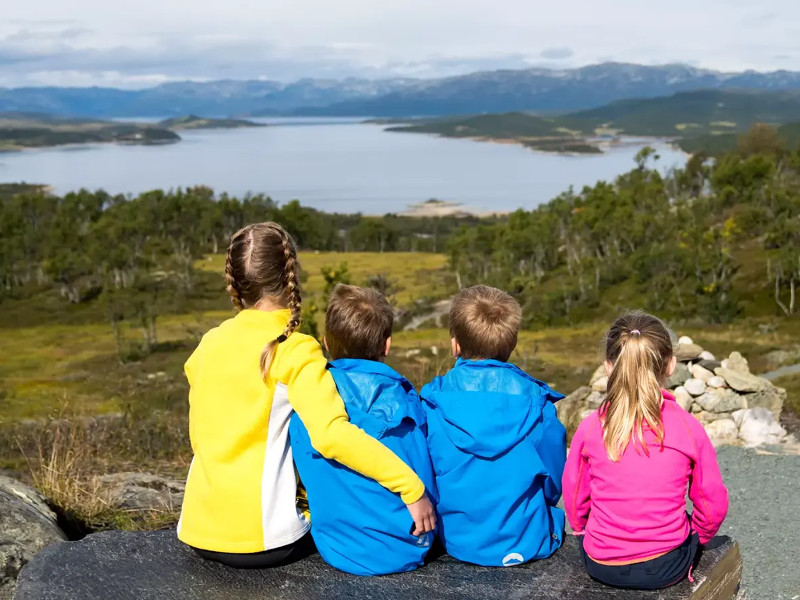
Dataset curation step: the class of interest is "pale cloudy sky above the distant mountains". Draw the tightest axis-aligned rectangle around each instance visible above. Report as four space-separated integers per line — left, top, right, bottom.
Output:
0 0 800 88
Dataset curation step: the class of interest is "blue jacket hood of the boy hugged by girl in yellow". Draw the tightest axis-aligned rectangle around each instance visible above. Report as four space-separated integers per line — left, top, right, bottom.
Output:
328 358 425 438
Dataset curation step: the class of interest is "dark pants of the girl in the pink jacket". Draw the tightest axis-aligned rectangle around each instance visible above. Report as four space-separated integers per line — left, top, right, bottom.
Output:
579 533 700 590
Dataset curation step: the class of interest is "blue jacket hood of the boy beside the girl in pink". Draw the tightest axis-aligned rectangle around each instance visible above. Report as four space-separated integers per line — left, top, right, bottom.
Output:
421 359 564 458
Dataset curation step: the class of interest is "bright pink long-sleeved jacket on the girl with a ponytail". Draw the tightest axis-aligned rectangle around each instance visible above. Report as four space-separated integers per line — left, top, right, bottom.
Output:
563 391 728 563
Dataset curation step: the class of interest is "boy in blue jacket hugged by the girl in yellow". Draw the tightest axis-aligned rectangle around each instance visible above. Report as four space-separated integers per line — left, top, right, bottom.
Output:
289 284 435 575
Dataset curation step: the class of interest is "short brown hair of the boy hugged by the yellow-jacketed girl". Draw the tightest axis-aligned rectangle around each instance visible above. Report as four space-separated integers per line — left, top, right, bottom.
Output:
325 283 394 360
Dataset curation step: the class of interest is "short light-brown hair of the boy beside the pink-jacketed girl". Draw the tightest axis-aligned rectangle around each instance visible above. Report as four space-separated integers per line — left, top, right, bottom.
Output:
450 285 522 362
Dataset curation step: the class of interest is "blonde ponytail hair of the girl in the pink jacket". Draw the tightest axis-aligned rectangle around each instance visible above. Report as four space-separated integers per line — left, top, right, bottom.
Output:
599 312 673 461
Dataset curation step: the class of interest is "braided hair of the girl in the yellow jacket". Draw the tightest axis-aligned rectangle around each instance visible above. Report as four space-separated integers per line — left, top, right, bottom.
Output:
225 222 303 379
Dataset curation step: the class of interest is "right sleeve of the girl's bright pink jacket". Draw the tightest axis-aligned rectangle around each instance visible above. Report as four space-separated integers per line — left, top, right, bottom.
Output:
689 417 728 544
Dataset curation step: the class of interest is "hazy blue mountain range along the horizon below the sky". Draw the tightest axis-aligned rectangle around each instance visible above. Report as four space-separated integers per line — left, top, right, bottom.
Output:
0 63 800 118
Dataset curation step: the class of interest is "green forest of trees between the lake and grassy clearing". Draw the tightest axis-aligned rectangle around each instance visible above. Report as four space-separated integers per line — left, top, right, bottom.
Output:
0 126 800 340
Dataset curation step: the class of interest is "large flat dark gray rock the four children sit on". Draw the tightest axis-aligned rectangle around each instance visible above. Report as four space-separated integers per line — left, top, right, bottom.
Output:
16 531 742 600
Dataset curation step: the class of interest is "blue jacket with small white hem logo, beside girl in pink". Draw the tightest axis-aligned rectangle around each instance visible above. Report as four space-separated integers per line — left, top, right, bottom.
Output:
420 359 567 567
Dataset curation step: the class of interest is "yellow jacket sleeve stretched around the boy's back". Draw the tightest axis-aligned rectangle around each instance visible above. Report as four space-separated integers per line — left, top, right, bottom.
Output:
270 335 425 504
